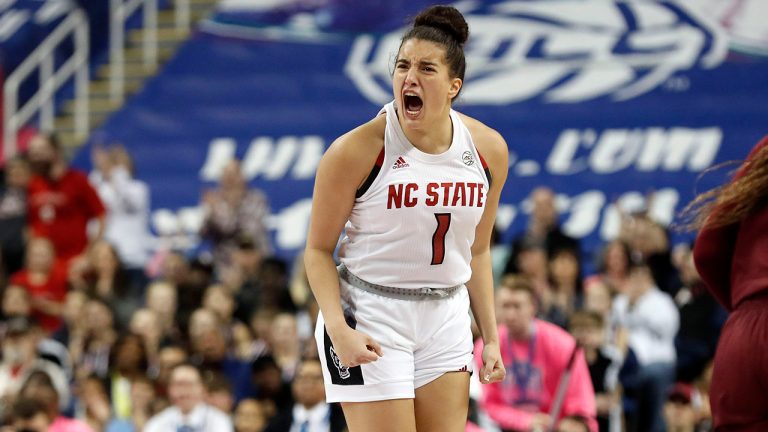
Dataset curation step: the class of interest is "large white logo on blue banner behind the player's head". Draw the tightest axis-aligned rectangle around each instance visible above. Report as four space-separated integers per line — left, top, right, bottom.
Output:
345 0 728 105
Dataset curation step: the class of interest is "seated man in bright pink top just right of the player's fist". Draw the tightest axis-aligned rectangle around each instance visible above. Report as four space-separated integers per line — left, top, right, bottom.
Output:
475 278 597 432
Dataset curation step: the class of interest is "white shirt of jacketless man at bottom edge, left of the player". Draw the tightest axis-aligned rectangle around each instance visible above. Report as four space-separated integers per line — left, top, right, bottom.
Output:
144 403 234 432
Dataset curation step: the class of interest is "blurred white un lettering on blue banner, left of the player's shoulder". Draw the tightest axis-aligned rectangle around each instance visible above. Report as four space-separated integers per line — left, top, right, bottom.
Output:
200 135 325 181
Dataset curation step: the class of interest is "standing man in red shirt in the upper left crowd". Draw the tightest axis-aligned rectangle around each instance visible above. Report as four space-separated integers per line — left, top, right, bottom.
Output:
28 135 106 261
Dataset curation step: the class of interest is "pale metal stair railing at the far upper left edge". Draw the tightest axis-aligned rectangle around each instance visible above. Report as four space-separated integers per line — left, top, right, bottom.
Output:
3 9 89 160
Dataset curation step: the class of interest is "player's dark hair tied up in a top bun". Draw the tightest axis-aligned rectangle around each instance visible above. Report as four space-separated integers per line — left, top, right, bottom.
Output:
398 5 469 96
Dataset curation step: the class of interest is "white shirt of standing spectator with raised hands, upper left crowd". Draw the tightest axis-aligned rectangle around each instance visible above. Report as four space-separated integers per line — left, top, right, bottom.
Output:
89 166 151 269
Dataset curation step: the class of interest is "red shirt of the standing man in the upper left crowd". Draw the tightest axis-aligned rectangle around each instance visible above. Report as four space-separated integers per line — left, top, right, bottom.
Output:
28 169 105 260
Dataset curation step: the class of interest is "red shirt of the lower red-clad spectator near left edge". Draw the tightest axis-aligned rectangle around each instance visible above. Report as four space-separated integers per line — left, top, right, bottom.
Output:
10 260 67 334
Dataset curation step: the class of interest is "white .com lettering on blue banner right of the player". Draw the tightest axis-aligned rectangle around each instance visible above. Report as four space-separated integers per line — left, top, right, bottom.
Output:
546 127 723 175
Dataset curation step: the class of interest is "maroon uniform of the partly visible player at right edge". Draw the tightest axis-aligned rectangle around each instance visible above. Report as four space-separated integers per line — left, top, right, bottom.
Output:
694 137 768 431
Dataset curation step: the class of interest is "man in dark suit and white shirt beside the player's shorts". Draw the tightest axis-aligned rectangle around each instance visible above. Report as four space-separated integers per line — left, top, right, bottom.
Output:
265 359 346 432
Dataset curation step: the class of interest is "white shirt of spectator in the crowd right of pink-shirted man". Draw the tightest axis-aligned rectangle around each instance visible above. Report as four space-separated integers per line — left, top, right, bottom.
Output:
613 287 680 366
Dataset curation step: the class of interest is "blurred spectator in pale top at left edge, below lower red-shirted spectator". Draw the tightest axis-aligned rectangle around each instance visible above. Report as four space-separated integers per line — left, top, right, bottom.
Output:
0 317 70 412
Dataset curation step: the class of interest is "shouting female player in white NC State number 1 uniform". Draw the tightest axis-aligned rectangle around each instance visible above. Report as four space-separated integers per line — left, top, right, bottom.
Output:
305 6 508 432
